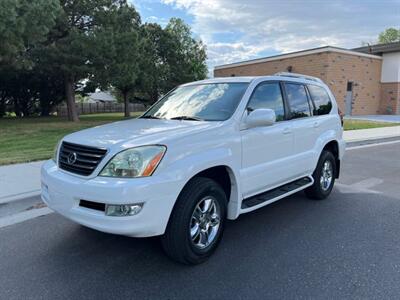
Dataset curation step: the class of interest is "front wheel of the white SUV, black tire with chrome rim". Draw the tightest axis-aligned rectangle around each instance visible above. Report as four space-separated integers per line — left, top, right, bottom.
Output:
161 177 227 265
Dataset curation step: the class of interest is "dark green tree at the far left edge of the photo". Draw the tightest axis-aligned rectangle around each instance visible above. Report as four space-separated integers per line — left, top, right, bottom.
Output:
0 0 61 117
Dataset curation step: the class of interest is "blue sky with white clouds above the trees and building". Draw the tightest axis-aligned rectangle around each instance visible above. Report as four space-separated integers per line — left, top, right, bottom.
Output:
131 0 400 73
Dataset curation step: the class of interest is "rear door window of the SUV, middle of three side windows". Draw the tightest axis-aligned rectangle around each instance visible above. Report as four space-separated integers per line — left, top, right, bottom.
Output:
285 83 311 119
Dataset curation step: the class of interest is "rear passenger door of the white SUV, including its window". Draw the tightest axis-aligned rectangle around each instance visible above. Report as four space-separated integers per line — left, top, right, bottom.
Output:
284 82 319 177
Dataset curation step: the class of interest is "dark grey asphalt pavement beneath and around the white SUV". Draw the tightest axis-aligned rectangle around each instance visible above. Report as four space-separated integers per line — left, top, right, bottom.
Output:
0 143 400 299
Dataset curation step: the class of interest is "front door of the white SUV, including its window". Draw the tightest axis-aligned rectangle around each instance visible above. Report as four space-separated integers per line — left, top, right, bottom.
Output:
240 81 294 198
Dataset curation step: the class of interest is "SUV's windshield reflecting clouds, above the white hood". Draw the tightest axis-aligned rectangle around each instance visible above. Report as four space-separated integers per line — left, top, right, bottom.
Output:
142 83 248 121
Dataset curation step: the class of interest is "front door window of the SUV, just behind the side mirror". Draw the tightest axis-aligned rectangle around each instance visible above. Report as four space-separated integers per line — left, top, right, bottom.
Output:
247 82 285 121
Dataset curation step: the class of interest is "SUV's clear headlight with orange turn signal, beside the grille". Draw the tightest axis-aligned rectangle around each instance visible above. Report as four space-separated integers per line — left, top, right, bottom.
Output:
100 146 167 178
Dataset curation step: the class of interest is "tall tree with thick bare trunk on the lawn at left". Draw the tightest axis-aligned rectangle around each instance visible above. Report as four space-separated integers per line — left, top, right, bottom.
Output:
42 0 121 121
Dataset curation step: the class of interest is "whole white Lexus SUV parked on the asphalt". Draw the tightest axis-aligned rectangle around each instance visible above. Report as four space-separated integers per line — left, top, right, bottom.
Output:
42 73 345 264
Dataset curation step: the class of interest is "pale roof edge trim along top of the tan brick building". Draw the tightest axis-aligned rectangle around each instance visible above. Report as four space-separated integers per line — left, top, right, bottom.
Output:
214 46 382 70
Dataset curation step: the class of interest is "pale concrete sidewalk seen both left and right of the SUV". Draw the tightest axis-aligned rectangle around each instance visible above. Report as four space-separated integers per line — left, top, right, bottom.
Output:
0 126 400 204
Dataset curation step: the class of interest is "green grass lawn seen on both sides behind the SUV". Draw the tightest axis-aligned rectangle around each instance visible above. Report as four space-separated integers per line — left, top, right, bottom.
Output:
0 113 400 165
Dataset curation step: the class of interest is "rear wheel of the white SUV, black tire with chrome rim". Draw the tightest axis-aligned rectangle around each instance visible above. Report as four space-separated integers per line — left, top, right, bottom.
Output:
305 150 336 200
